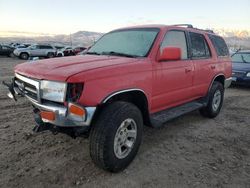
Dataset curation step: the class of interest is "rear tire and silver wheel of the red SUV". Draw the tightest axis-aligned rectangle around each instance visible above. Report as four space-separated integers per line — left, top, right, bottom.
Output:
200 81 224 118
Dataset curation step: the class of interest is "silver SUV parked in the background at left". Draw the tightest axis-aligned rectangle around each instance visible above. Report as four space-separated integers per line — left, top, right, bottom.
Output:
13 44 56 59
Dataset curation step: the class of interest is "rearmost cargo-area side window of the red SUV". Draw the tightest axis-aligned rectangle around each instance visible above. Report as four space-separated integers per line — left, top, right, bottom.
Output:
209 35 229 56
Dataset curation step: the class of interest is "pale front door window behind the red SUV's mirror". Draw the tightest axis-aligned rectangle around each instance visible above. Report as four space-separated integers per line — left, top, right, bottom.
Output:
161 31 188 59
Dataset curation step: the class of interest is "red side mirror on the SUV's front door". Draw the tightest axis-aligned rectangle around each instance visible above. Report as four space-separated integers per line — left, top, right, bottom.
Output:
158 47 181 61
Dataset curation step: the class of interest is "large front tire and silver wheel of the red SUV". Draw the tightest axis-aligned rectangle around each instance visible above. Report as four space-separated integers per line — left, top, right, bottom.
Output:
90 102 143 172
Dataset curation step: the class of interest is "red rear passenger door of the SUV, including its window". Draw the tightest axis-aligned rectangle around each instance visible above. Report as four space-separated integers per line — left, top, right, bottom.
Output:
189 32 215 97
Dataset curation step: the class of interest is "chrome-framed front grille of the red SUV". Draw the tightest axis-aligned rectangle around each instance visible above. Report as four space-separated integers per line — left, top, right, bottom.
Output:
15 75 39 101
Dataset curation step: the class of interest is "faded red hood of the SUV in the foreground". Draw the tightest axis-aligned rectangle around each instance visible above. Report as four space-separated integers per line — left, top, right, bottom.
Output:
15 55 138 81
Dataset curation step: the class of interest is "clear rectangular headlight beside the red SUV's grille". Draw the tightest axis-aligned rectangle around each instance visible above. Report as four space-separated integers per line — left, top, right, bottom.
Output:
41 80 67 102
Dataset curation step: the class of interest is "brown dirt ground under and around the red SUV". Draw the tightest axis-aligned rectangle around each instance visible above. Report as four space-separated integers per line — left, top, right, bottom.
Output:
0 58 250 188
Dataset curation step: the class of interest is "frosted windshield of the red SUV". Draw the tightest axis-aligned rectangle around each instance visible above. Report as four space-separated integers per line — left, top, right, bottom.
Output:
87 28 159 57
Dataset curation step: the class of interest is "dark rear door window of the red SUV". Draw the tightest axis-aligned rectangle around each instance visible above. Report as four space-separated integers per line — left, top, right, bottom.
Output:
189 32 211 59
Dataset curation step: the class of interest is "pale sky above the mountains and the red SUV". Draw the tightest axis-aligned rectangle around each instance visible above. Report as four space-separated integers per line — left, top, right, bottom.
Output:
0 0 250 36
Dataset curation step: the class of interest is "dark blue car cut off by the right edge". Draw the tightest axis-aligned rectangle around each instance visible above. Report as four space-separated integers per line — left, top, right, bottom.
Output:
232 50 250 86
